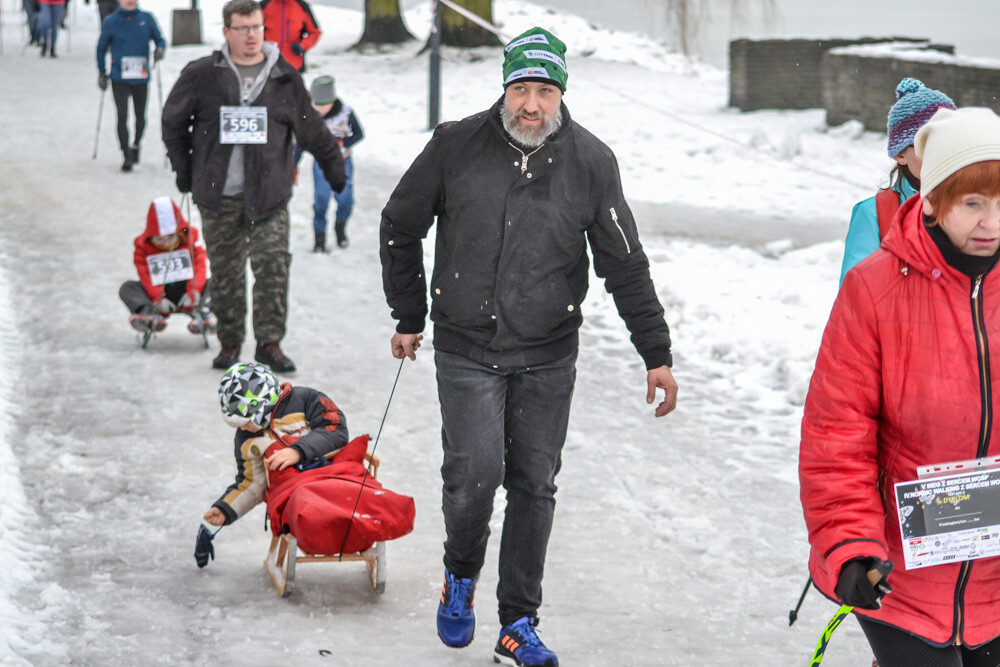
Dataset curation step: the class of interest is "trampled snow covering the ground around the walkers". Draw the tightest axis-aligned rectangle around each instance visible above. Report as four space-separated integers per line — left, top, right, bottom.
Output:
0 0 916 667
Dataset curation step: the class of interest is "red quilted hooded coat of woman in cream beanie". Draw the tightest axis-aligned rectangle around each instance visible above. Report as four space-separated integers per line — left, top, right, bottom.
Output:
799 196 1000 646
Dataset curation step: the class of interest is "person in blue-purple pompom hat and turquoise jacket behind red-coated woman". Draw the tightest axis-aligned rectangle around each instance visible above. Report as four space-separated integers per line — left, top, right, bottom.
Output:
840 77 955 283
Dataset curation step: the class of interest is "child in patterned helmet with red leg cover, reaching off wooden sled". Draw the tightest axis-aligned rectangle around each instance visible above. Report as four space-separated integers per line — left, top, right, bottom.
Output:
195 363 415 567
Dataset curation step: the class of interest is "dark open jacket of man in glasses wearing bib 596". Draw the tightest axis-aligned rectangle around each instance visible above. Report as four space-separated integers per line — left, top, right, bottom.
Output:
163 43 347 220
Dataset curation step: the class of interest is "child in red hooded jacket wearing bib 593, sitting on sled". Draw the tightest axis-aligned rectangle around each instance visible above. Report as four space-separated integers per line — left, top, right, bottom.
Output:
118 197 216 334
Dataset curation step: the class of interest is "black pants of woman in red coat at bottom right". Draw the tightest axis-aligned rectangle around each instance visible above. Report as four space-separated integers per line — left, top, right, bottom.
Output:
857 616 1000 667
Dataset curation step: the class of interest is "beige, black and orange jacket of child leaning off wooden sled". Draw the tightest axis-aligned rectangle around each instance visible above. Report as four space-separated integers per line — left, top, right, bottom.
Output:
213 383 347 524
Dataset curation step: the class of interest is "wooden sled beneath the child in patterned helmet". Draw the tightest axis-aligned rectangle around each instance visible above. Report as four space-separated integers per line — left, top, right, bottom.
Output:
264 452 386 597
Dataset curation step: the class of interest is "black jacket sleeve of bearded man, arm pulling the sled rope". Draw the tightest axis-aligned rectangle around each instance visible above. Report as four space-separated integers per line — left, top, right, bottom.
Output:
379 127 443 334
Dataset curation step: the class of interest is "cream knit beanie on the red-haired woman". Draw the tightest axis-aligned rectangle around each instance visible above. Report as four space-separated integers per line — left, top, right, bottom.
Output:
913 107 1000 197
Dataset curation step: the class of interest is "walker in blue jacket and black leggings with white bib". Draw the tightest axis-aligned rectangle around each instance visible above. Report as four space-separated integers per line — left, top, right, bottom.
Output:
97 0 167 171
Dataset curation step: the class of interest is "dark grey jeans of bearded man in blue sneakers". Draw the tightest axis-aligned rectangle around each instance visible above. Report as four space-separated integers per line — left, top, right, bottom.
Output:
434 351 577 625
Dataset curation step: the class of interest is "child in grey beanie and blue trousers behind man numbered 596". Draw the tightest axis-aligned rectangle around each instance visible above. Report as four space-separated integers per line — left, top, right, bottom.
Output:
310 76 365 252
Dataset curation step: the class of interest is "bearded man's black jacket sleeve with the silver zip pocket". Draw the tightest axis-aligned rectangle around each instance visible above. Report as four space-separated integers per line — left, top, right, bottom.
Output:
587 148 673 370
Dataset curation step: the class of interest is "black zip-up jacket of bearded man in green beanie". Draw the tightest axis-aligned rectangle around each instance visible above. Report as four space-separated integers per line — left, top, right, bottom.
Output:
381 97 671 368
